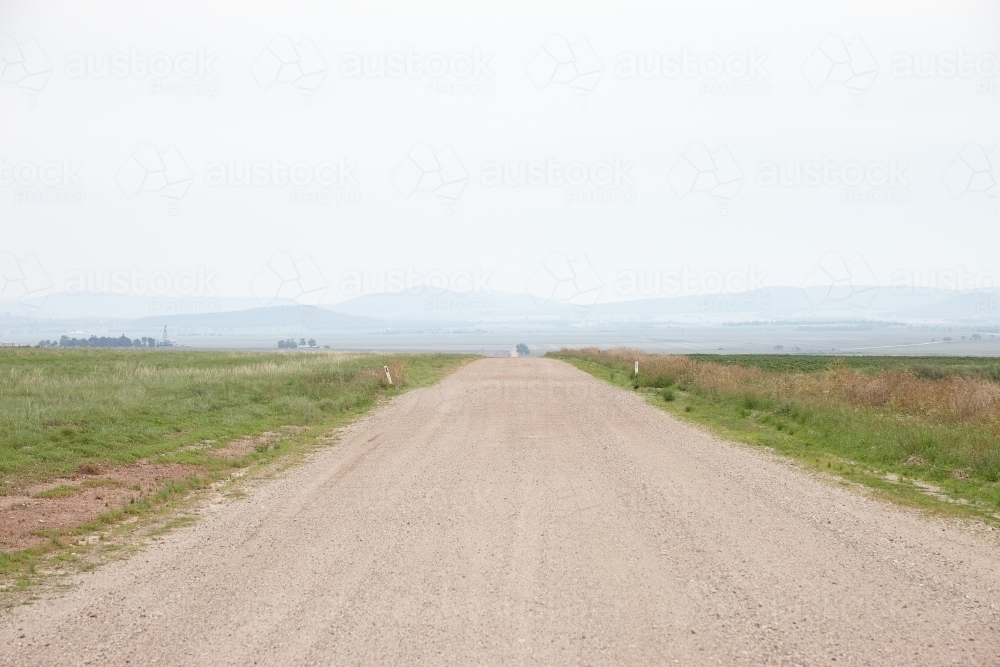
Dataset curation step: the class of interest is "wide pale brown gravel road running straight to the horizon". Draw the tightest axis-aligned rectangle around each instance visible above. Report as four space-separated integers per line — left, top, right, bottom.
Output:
0 359 1000 667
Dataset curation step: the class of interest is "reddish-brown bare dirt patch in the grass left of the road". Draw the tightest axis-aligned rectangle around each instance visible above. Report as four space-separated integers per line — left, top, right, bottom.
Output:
0 463 199 551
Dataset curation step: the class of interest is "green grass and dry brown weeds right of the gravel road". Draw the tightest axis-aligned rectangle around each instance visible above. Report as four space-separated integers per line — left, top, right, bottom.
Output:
549 349 1000 525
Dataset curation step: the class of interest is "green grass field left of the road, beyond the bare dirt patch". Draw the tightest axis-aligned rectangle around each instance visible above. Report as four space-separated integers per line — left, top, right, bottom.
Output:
0 349 463 493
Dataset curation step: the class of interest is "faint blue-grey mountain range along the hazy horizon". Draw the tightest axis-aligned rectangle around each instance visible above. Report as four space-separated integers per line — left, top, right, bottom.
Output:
0 286 1000 330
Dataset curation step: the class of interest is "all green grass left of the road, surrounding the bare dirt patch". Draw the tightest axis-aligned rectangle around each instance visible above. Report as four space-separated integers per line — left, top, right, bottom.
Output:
0 349 471 591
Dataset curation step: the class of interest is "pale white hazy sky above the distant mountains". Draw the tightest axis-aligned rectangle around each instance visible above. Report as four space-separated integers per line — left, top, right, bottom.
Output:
0 0 1000 302
